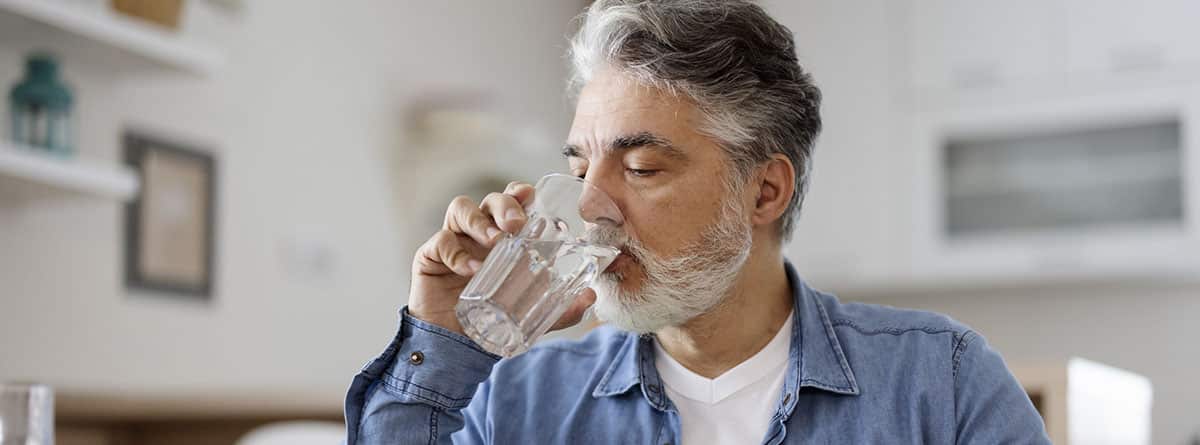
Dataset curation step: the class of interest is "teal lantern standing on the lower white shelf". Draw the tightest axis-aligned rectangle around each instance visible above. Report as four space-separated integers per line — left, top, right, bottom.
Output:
8 54 74 156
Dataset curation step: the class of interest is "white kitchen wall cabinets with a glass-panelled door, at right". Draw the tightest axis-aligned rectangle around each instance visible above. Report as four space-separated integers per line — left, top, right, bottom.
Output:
878 0 1200 293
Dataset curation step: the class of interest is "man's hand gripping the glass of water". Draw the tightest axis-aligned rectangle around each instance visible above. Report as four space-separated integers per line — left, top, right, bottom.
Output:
408 182 595 333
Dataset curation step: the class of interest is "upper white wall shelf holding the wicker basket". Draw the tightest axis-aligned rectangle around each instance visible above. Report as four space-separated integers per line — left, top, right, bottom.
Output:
0 0 224 76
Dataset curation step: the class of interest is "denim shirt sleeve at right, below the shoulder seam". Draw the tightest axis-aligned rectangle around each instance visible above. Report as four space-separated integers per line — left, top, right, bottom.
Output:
954 331 1050 444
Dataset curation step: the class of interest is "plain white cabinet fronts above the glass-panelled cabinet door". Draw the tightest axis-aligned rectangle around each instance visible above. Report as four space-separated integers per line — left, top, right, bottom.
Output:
895 0 1200 98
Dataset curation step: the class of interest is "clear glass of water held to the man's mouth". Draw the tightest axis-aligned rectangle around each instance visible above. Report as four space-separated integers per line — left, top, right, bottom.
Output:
455 174 624 357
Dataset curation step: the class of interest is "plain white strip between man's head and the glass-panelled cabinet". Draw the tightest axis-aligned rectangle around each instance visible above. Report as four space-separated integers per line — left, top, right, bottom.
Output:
763 0 898 284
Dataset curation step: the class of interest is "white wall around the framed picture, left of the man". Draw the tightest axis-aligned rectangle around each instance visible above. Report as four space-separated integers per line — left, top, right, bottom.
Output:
0 0 580 407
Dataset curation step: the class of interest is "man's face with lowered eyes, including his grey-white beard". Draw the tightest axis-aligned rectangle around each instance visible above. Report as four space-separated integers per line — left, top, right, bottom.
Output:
565 71 750 331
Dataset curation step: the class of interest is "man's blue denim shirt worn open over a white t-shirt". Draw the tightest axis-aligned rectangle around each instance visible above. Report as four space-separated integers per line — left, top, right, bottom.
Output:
346 264 1050 445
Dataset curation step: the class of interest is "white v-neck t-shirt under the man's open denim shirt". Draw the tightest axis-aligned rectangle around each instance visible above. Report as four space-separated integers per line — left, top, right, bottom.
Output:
654 315 792 445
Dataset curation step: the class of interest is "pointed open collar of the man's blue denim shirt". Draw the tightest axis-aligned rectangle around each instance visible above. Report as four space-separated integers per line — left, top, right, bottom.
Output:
592 261 859 419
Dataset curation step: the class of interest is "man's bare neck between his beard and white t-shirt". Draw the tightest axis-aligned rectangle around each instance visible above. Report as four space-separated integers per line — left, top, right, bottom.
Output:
654 242 792 379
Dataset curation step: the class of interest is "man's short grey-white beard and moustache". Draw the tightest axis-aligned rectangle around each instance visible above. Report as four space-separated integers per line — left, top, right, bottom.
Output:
592 193 752 332
